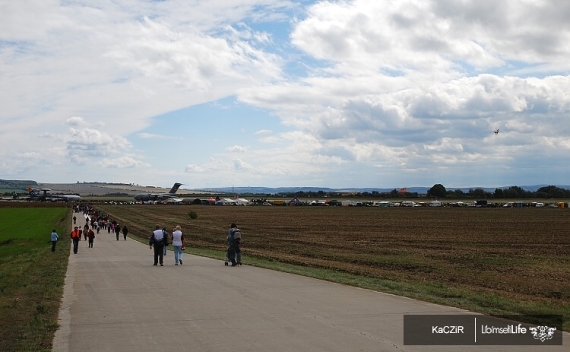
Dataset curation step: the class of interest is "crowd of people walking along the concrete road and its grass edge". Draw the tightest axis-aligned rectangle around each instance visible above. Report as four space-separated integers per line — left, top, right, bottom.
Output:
61 205 241 266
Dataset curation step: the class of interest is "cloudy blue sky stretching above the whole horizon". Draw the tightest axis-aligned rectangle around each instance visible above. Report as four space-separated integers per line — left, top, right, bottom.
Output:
0 0 570 189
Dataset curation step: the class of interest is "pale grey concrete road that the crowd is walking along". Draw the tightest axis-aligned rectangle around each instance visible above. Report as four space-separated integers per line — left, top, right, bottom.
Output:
53 214 570 352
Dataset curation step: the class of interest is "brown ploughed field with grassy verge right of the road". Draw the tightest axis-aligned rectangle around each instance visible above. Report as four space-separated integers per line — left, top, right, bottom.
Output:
98 205 570 331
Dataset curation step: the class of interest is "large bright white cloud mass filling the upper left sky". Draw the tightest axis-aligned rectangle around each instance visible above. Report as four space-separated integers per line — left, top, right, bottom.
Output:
0 0 284 176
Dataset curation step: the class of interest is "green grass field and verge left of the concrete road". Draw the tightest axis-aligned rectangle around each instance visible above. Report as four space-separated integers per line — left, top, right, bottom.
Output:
0 207 71 351
